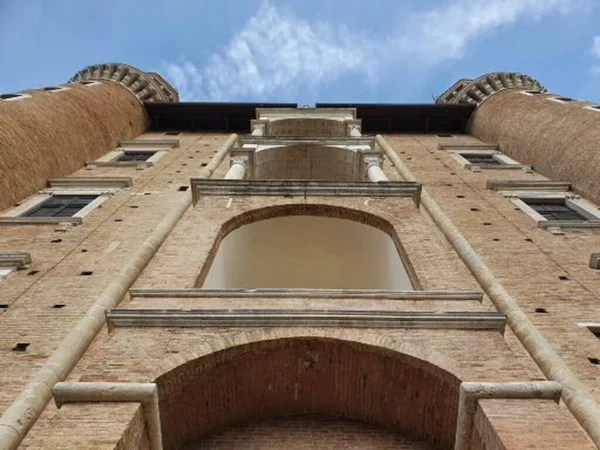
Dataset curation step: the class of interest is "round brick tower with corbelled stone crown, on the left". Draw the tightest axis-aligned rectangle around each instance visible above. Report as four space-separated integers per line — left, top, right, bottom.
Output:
0 64 178 209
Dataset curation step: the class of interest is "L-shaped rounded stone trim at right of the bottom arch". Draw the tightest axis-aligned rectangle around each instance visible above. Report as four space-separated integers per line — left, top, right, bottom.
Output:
454 381 562 450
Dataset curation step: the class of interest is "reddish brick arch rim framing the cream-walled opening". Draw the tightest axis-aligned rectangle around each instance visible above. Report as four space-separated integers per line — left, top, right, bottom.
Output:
195 203 421 289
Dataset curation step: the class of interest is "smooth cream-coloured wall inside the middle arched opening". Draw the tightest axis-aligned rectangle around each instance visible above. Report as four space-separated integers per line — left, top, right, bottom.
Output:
199 215 413 290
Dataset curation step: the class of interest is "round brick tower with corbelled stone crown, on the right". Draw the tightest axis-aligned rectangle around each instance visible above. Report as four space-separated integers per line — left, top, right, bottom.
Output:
438 73 600 203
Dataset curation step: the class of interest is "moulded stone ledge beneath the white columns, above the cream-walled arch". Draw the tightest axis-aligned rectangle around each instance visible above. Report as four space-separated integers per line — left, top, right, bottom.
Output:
191 178 421 206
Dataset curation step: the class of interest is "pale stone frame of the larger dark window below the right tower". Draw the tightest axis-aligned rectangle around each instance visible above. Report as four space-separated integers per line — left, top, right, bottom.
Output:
502 191 600 231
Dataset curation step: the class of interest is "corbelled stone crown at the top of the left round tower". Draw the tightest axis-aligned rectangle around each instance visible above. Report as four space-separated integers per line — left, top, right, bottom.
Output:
69 63 179 102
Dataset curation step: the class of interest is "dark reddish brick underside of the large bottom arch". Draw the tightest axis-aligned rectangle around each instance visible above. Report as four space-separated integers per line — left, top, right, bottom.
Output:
156 335 460 450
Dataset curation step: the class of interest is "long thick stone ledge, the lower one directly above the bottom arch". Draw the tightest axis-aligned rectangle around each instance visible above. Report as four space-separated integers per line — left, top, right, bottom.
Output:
106 309 506 334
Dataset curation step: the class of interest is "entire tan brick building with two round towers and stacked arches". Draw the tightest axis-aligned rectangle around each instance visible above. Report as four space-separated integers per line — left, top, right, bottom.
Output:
0 64 600 450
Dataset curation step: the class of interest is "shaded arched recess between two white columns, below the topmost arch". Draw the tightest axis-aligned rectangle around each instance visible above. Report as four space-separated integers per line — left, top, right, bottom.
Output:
253 143 366 181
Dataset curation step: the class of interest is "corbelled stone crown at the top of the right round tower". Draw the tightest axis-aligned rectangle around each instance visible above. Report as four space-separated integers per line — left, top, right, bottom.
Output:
436 72 547 105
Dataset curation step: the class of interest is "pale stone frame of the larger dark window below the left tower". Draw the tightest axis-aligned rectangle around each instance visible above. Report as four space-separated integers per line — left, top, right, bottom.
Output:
0 187 120 225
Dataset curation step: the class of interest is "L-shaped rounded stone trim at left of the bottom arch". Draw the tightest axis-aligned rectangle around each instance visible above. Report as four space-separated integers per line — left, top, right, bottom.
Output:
52 382 163 450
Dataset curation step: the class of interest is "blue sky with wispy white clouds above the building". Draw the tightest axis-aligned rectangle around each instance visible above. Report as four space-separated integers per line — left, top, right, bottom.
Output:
0 0 600 104
